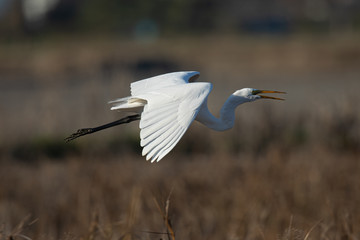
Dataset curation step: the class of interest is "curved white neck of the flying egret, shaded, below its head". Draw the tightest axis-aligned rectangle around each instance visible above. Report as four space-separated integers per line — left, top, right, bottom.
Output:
196 95 251 131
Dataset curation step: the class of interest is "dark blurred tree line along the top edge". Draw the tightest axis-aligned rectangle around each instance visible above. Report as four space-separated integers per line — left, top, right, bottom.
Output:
0 0 360 37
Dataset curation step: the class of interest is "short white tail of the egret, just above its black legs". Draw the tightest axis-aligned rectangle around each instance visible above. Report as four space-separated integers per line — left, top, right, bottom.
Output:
109 96 147 112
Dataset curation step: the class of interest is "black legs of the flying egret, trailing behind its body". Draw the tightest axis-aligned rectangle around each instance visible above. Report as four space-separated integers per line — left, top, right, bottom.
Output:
64 114 141 142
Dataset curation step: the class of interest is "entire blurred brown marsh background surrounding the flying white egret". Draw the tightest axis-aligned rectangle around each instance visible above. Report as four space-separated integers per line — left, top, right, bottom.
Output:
0 0 360 239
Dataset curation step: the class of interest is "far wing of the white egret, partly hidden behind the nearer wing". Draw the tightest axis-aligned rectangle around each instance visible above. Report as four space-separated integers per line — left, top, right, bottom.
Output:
130 71 200 96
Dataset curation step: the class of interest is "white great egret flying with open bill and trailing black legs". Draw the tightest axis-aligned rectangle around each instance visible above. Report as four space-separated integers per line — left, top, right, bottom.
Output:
65 71 285 162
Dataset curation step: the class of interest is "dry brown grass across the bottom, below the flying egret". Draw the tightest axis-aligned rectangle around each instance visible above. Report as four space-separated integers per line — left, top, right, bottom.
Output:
0 145 360 239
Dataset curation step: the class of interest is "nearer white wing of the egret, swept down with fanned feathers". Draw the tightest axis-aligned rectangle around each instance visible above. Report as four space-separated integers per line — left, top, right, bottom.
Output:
136 83 212 162
